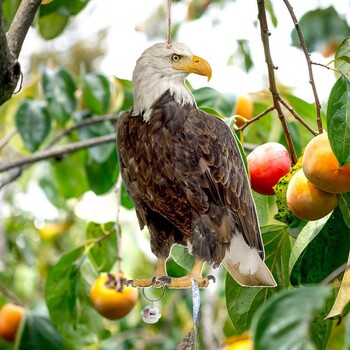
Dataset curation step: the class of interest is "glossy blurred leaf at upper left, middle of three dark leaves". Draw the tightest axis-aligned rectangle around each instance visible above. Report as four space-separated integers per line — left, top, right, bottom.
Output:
42 68 77 125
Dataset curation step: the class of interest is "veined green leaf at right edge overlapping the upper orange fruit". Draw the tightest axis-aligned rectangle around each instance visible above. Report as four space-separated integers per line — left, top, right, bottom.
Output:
327 76 350 166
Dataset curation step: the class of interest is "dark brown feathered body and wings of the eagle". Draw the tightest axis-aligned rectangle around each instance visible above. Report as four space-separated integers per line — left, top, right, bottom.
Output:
117 91 264 267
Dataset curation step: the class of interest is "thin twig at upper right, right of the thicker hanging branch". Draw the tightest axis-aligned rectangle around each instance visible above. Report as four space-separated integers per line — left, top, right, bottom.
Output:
283 0 323 134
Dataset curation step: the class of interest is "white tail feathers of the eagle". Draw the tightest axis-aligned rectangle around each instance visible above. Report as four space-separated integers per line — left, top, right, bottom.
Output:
223 234 276 287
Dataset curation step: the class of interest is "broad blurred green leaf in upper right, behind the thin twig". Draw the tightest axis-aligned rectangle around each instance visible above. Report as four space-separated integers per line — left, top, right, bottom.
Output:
292 6 350 51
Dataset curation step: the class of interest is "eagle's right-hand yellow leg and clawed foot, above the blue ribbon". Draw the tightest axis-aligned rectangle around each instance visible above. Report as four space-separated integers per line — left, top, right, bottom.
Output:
157 260 215 289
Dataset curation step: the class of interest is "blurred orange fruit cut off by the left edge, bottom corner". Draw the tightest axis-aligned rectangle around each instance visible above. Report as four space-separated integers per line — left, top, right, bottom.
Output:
0 303 25 342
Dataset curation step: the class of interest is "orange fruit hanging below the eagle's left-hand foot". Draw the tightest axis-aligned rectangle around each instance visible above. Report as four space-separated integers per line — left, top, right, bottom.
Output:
90 274 138 320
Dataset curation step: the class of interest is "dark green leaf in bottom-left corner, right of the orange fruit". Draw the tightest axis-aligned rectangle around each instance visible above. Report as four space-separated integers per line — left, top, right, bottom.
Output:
15 310 64 350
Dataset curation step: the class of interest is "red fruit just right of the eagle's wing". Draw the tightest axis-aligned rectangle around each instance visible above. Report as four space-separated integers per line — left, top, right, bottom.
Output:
247 142 291 195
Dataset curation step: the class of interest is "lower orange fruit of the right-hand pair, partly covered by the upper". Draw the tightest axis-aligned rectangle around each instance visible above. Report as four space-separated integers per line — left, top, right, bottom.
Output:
286 169 338 221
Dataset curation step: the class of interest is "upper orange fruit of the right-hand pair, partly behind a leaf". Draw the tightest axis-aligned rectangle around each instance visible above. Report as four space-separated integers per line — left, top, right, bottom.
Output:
303 132 350 194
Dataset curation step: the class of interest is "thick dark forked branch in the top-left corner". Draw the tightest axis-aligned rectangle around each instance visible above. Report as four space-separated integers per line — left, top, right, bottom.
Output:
0 0 41 106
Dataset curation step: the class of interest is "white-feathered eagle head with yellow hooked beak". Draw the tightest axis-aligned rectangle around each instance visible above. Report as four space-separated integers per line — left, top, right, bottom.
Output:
132 42 211 121
